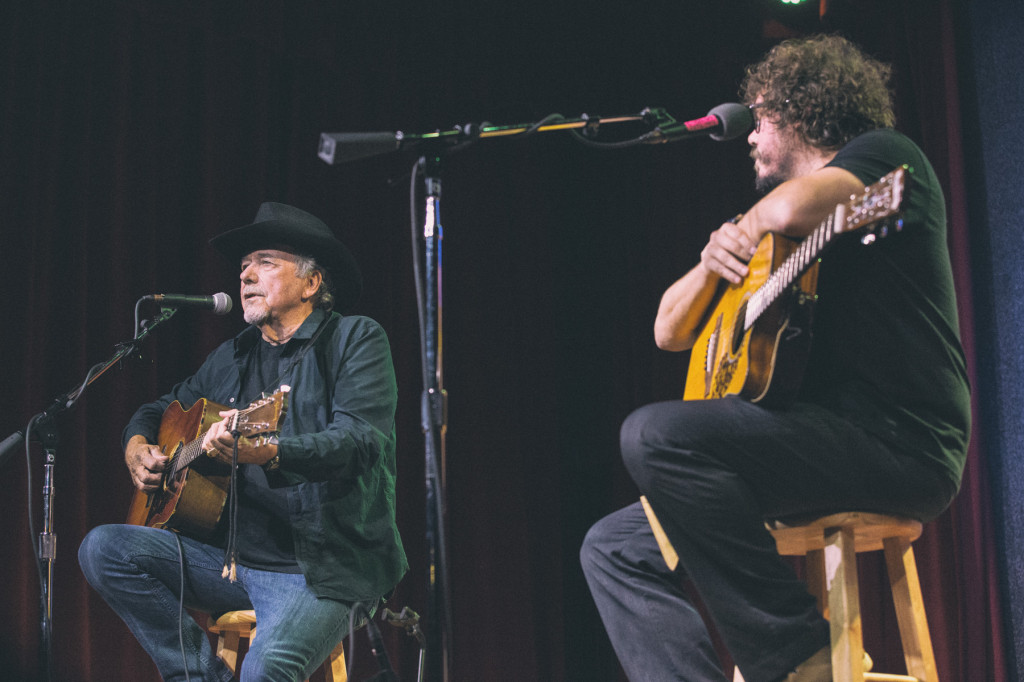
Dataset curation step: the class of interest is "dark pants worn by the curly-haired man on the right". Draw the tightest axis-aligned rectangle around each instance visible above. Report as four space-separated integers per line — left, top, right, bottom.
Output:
581 397 955 682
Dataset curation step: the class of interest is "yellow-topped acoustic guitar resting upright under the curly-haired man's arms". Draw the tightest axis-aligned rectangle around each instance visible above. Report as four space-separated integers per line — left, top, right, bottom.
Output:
683 166 912 404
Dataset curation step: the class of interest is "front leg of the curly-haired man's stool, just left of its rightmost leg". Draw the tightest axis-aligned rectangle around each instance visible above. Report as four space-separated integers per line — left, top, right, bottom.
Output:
825 527 864 682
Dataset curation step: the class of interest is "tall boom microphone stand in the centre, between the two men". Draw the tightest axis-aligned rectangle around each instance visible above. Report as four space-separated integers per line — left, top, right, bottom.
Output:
317 108 704 682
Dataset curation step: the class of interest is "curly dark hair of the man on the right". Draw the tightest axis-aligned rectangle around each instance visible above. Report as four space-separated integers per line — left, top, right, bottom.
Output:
739 36 896 150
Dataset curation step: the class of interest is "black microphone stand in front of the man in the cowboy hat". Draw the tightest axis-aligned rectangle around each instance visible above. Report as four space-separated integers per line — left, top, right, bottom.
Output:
11 299 177 680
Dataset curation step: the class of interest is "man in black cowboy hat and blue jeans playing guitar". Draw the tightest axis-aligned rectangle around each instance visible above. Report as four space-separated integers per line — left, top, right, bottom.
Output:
79 203 408 681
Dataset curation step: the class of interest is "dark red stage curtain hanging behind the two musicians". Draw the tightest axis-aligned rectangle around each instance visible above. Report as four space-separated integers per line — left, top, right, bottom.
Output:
0 0 1011 682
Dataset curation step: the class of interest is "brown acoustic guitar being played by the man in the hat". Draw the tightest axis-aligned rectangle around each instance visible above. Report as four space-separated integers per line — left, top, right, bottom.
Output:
128 386 291 540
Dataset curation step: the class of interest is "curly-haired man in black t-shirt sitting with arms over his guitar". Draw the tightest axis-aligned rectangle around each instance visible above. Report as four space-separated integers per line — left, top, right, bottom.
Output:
581 36 970 682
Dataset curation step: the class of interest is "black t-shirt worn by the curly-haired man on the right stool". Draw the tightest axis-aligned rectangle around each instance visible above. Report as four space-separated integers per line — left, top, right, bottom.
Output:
801 129 971 483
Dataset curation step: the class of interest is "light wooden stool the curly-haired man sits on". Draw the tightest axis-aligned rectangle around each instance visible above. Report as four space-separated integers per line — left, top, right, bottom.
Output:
640 497 939 682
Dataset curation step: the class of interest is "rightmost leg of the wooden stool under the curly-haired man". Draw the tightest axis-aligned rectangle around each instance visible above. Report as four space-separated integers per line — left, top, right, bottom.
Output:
883 538 939 682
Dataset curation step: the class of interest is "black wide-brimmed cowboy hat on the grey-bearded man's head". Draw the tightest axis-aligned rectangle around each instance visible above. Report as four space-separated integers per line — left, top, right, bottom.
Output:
210 202 362 310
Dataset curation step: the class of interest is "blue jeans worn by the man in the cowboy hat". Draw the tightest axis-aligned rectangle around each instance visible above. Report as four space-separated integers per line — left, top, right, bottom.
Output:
78 525 362 682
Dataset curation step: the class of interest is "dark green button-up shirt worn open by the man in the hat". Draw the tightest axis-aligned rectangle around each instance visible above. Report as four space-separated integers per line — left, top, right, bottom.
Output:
124 310 409 601
